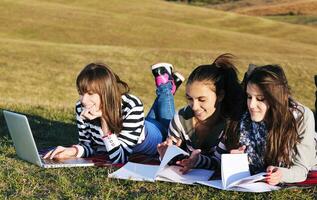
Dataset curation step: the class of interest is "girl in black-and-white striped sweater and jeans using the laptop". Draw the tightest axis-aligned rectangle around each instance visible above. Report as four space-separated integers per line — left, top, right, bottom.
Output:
44 63 183 163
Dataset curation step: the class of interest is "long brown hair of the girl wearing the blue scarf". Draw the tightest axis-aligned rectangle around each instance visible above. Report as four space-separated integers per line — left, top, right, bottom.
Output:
246 65 303 166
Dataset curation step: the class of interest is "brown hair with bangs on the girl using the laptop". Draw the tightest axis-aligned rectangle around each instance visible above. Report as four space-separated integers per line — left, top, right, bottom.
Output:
76 63 129 133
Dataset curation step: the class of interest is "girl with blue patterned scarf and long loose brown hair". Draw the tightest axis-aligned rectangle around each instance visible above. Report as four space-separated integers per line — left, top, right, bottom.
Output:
218 65 317 185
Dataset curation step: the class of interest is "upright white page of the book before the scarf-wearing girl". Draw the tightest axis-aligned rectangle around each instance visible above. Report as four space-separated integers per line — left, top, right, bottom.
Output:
221 154 250 189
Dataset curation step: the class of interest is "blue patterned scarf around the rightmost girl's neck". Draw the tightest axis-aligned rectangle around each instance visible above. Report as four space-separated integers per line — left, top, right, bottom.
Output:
239 112 267 174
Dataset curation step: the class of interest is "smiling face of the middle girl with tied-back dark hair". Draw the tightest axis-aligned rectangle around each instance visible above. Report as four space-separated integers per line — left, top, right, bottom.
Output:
186 81 217 121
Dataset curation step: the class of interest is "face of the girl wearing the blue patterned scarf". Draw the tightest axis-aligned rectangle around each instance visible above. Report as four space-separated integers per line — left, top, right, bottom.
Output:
247 83 269 122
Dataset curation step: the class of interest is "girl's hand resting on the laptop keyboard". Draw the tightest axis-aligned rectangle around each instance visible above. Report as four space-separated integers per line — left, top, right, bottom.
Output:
43 146 77 159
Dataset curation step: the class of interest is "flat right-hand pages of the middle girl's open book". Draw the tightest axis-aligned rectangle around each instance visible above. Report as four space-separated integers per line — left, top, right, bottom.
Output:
156 165 214 184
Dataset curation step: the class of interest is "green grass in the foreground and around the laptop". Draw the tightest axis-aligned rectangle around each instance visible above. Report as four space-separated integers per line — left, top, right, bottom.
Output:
0 106 316 199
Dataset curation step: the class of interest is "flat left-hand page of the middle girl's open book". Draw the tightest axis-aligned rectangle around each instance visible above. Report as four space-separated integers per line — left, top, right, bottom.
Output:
108 162 159 182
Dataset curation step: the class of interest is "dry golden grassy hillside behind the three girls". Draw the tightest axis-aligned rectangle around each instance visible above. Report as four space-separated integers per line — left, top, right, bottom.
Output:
0 0 317 107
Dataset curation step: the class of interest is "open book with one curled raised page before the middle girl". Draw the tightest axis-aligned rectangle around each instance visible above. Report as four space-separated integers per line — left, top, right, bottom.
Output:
108 145 213 184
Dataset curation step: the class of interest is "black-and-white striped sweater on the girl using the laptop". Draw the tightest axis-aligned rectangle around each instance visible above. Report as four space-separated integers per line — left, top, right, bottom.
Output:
76 94 145 163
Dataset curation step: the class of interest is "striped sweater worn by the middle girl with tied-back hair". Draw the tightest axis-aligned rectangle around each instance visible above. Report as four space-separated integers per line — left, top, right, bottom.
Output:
168 106 224 169
